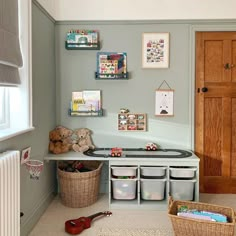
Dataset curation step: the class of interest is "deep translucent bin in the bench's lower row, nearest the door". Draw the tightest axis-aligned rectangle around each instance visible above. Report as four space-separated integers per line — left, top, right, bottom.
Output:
170 179 196 201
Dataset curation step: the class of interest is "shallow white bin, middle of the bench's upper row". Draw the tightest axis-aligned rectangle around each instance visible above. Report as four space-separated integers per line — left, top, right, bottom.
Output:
140 166 167 178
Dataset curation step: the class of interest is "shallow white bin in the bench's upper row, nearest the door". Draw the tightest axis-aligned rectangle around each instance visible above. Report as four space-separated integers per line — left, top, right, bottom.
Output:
170 167 197 179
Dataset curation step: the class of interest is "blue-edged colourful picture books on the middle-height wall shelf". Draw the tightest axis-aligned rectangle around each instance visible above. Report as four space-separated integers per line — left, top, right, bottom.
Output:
97 52 127 78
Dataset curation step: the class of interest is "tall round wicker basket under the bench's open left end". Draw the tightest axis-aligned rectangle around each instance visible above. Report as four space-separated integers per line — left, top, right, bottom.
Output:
57 161 103 207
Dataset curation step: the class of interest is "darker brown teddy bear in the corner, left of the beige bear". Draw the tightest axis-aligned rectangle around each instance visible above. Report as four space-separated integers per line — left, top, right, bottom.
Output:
48 125 73 154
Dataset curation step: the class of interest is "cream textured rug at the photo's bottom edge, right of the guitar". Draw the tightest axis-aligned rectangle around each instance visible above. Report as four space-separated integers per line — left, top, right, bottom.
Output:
96 228 174 236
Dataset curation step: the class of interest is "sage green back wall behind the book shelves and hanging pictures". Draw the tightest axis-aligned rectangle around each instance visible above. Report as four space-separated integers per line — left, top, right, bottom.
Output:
56 21 191 148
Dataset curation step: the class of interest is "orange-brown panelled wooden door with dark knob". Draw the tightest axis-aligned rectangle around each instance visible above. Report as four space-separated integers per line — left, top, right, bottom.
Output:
195 32 236 193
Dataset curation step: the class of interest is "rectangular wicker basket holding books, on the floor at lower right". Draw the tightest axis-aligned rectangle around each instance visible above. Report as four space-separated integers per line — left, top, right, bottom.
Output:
168 199 235 236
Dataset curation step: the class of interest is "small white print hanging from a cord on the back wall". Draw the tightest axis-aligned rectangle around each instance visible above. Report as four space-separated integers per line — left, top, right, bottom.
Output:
155 89 174 116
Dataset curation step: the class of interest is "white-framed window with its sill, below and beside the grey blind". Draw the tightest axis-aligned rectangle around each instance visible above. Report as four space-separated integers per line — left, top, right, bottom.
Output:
0 0 33 141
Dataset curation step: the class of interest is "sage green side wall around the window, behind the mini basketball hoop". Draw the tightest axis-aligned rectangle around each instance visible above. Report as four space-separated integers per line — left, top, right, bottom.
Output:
0 3 56 236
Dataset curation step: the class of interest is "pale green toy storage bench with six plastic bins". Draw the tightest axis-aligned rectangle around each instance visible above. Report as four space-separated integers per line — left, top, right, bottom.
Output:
44 152 199 210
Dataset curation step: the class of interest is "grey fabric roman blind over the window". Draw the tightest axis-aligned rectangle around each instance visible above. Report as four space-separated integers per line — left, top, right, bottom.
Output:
0 0 23 86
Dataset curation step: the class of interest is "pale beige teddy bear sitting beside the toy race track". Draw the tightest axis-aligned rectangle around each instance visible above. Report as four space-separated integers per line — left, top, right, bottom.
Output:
72 128 95 152
